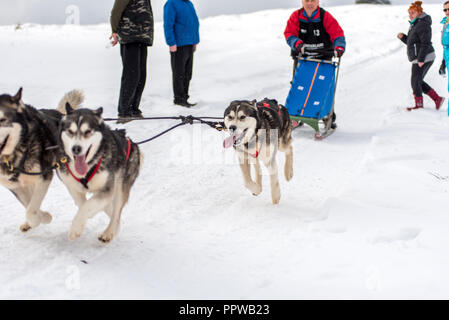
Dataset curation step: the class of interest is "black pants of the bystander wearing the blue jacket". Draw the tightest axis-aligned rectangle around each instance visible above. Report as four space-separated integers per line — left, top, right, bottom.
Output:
170 45 193 103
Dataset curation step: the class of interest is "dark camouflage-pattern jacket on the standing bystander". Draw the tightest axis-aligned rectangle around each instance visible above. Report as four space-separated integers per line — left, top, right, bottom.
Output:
111 0 154 46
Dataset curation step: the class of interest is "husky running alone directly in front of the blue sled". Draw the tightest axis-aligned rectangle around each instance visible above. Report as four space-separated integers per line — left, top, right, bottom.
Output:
223 98 293 204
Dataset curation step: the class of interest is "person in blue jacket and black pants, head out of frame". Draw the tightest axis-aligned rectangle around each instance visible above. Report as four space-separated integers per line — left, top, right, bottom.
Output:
164 0 200 108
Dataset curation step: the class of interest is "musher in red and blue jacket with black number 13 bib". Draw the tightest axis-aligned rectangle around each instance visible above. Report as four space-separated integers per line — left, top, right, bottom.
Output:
284 0 346 128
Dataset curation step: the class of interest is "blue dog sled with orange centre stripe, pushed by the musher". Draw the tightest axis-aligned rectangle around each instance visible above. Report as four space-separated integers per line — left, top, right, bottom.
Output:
285 57 340 140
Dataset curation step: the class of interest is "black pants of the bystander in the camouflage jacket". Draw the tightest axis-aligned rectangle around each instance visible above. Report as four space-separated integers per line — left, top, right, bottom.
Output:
118 42 148 116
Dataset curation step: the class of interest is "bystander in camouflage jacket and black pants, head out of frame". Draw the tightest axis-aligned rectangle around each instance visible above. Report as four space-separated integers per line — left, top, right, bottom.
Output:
109 0 154 123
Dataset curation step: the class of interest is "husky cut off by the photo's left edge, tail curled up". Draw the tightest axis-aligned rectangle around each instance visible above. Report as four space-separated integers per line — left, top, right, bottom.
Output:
0 88 83 232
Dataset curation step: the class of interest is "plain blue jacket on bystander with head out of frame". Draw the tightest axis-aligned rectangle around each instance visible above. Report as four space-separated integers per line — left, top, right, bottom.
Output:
164 0 200 47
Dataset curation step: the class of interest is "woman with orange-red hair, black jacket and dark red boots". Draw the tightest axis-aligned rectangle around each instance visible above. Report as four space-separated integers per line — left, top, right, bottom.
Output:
398 1 444 111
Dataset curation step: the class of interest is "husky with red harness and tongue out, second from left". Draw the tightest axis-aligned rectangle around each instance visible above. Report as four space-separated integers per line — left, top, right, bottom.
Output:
57 104 142 243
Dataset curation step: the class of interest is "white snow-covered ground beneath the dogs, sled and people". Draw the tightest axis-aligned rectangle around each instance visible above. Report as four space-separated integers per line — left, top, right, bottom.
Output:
0 5 449 299
